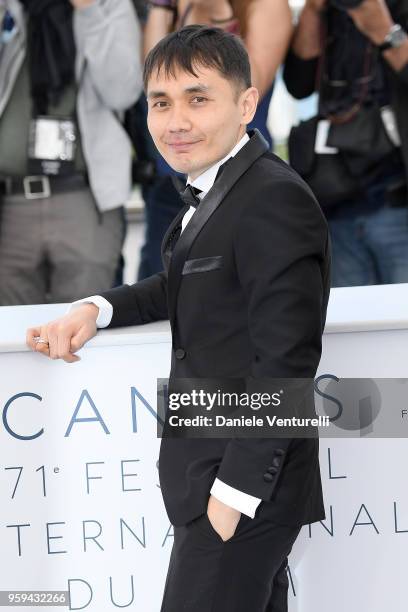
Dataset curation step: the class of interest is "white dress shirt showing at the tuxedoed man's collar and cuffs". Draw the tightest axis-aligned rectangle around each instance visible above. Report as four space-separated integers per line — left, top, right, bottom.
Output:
68 134 261 518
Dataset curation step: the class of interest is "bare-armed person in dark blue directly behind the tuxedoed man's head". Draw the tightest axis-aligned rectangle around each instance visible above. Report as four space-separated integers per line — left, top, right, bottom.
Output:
138 0 293 280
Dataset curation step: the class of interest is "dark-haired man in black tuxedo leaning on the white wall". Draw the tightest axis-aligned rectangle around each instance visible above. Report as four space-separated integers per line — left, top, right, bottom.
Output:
27 25 329 612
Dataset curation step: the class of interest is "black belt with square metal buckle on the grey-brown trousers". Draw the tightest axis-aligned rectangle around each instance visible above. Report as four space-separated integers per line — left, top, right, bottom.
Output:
0 174 89 200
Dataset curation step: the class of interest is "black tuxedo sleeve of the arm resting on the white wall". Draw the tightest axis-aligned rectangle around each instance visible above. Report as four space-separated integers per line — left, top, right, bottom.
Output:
99 272 168 328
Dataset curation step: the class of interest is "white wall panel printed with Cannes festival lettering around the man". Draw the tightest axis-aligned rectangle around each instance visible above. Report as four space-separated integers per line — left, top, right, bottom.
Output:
0 308 408 612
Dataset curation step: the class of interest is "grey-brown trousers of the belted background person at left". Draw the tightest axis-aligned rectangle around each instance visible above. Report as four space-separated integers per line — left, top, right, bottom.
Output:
0 187 124 306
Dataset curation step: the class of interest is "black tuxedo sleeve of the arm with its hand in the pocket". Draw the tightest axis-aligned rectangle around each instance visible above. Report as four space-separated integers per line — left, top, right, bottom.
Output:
217 179 329 500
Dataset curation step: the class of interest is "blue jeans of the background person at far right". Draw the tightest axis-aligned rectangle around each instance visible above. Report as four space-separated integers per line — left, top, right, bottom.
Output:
328 206 408 287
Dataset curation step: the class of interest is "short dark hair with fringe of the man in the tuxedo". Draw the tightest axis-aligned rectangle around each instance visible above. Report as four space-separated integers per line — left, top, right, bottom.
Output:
143 25 251 96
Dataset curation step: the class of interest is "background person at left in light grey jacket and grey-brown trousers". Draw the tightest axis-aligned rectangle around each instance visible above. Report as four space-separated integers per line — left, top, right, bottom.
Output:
0 0 142 306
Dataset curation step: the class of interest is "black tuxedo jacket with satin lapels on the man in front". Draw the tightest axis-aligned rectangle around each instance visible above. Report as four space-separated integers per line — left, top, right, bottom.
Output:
101 130 330 526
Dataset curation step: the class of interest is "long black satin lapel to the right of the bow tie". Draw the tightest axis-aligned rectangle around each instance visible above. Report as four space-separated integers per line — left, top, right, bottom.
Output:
168 129 269 323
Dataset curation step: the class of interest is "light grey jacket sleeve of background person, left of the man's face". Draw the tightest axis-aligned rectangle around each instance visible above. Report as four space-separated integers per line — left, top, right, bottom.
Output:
74 0 142 111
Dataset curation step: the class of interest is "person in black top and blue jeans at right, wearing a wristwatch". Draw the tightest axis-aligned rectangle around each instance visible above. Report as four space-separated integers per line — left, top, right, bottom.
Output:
284 0 408 287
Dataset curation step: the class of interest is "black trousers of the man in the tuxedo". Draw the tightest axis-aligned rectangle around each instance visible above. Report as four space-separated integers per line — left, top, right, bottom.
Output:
161 512 302 612
